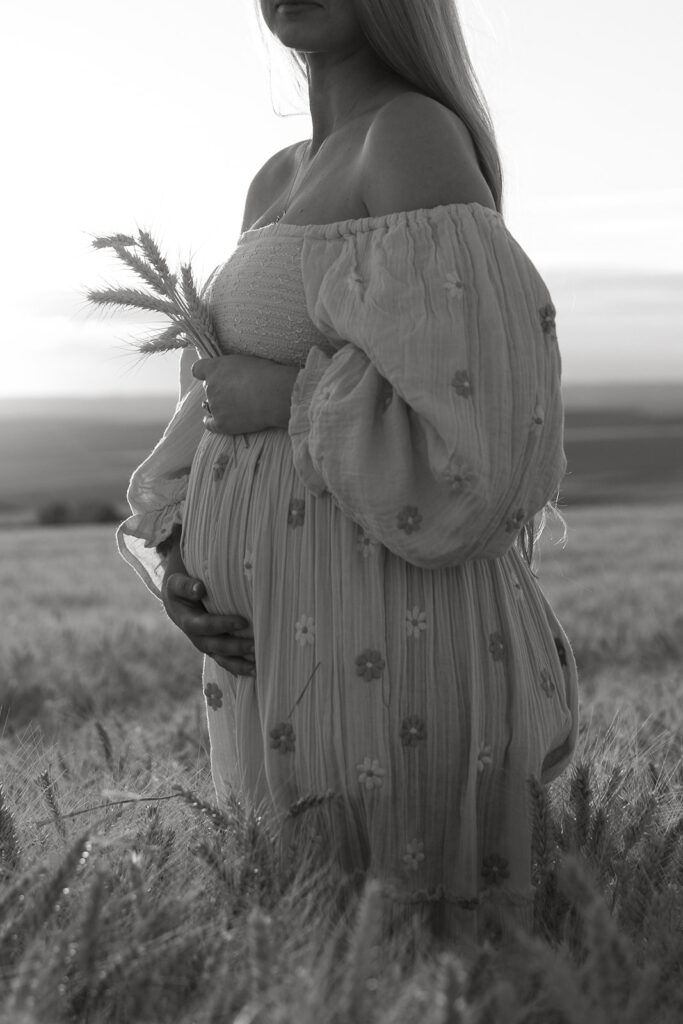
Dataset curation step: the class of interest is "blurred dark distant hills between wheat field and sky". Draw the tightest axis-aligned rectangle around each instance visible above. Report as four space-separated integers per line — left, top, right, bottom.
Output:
0 382 683 525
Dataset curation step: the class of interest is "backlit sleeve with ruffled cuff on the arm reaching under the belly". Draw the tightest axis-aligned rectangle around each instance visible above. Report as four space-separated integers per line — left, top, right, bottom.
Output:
117 348 204 597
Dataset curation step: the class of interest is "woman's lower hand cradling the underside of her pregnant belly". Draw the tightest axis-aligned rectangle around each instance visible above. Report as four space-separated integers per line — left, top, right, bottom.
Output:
161 544 255 676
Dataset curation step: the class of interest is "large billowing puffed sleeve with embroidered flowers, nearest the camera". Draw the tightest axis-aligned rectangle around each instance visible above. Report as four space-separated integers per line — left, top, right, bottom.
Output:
289 204 566 568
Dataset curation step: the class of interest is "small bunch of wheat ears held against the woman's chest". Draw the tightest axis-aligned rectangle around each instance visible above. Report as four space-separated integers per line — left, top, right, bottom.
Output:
87 230 222 357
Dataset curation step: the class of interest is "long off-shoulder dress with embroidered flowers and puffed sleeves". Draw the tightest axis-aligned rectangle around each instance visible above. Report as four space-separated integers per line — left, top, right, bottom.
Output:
119 204 578 938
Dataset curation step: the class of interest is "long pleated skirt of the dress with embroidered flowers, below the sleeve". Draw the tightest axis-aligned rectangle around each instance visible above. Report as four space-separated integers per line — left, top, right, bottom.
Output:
182 430 578 941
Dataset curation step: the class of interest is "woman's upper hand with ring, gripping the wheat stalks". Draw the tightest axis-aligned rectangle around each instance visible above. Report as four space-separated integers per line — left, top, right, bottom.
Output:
193 355 299 434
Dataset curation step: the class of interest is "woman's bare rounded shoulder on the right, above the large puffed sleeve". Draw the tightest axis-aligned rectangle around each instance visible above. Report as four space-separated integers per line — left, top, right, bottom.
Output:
361 91 496 217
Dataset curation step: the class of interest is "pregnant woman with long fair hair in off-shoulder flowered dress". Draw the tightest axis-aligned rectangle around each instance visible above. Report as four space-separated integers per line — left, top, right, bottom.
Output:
119 0 578 939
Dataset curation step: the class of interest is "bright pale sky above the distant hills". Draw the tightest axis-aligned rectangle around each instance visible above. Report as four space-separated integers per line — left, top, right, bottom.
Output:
0 0 683 397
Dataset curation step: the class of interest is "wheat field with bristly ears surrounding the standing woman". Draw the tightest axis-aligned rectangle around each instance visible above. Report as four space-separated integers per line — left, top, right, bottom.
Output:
0 505 683 1024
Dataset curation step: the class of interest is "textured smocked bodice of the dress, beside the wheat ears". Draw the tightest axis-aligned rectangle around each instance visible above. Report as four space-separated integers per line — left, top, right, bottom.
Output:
206 225 334 367
